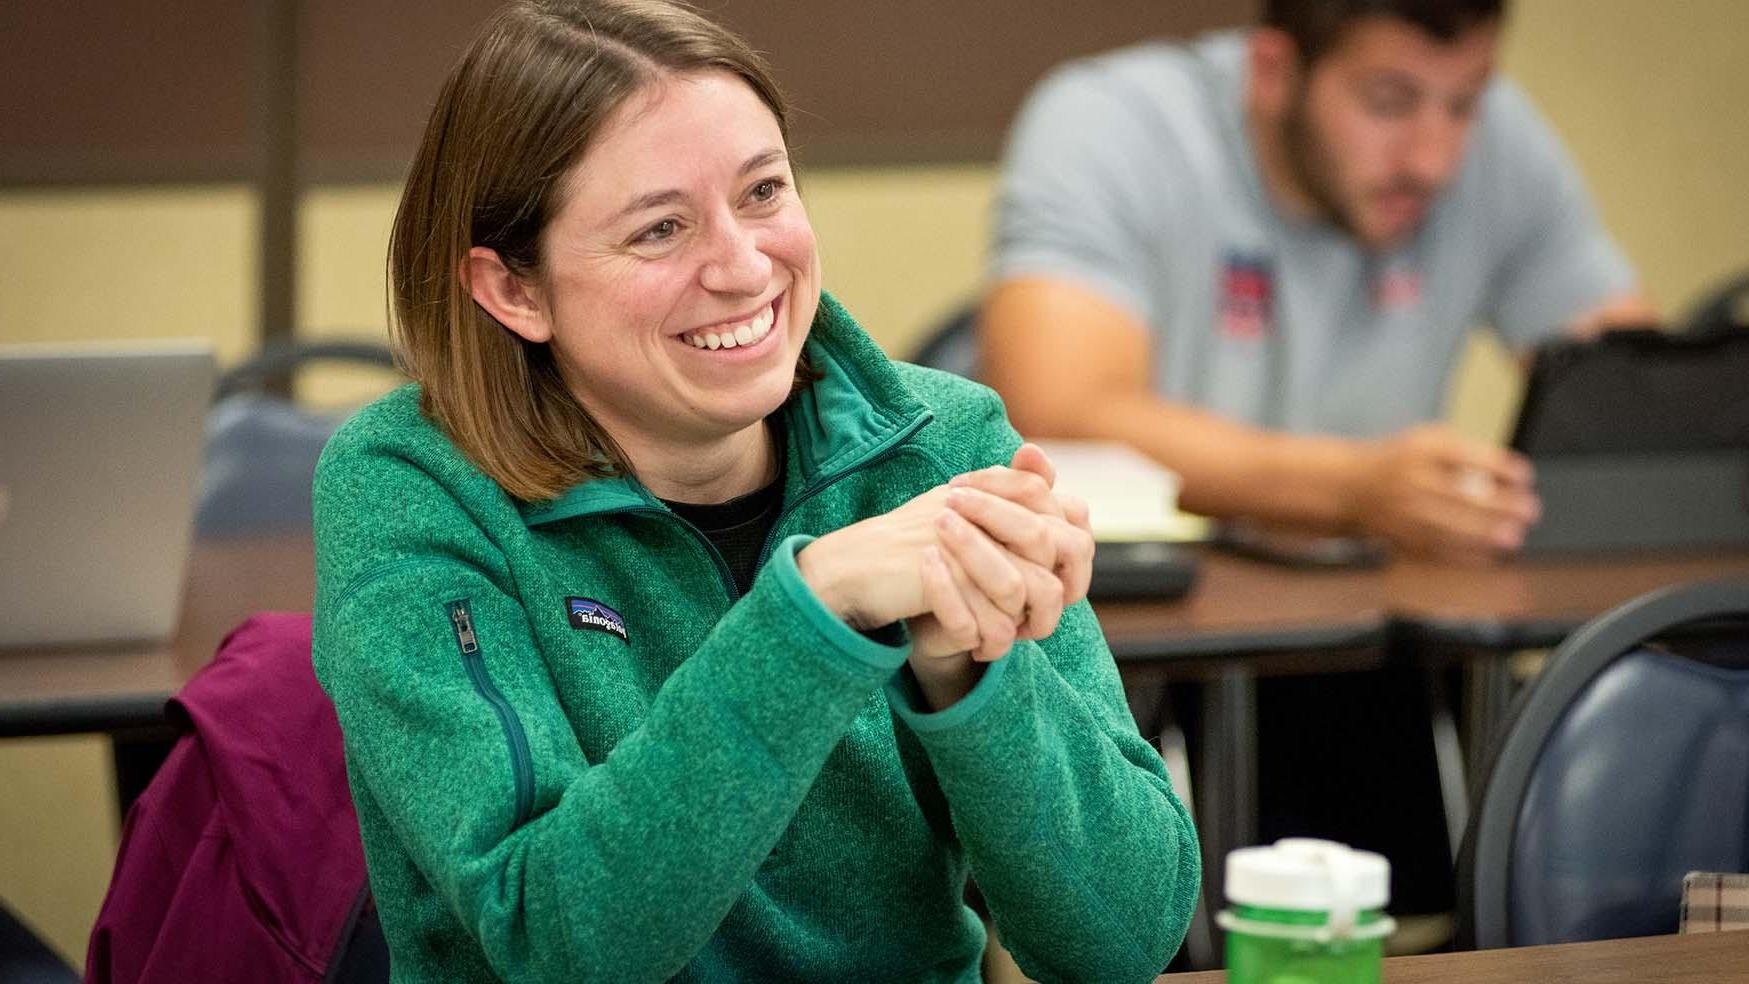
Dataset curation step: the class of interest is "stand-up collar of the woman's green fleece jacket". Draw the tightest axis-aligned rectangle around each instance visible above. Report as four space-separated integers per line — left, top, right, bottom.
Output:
521 294 930 526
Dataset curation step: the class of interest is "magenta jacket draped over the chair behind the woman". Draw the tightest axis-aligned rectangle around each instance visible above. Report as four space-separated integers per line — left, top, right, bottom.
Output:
86 613 369 984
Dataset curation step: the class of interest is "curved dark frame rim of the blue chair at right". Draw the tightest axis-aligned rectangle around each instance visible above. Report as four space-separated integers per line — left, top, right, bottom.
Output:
1459 580 1749 949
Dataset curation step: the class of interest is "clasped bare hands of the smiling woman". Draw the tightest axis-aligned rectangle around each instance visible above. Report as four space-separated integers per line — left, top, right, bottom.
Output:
796 444 1093 708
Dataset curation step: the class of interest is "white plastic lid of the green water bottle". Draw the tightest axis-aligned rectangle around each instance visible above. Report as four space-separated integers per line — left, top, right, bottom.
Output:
1226 837 1390 932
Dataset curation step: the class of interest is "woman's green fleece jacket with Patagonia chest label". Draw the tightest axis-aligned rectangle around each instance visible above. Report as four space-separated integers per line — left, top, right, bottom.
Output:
315 297 1200 984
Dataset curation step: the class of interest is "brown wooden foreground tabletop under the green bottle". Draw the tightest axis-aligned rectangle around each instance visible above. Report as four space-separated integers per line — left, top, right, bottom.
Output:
1154 932 1749 984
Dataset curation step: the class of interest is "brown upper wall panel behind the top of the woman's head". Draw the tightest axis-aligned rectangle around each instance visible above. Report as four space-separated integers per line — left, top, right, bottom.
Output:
304 0 1256 177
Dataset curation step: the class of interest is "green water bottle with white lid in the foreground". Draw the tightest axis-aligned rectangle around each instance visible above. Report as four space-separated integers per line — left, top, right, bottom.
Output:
1216 837 1396 984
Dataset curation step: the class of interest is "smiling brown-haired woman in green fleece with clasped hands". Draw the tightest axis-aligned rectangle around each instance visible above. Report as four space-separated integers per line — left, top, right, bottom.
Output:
315 0 1200 982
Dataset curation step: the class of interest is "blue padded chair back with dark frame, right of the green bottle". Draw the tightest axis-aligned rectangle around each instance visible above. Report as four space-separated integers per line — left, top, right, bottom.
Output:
1459 582 1749 947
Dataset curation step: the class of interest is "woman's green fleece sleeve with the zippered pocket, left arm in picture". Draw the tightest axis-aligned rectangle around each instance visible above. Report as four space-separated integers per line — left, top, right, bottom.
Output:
315 447 908 982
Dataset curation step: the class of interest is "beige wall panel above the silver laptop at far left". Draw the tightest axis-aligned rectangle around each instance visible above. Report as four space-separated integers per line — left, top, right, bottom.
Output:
0 185 257 362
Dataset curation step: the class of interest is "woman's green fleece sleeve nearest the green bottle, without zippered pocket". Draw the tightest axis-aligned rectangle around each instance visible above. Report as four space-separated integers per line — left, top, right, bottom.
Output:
888 381 1202 984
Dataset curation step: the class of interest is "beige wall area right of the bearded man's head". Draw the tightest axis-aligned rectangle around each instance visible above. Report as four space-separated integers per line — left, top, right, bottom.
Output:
1504 0 1749 316
